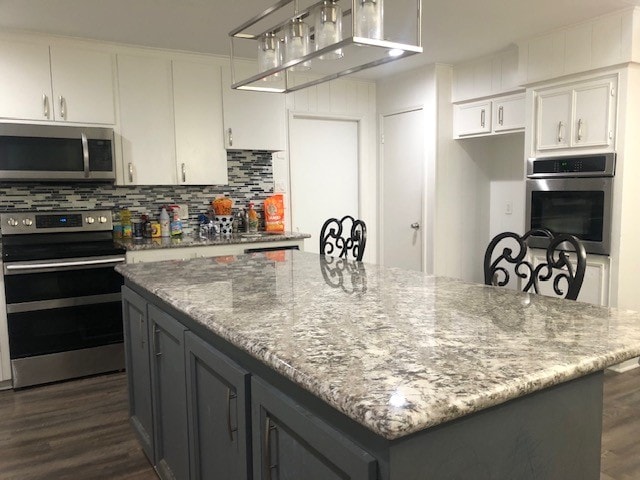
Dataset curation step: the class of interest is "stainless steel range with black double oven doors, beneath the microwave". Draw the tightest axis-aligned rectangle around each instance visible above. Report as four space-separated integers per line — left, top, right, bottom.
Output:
0 211 125 388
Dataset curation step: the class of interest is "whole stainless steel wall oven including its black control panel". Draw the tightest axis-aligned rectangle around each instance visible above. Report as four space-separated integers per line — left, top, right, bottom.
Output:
526 153 615 255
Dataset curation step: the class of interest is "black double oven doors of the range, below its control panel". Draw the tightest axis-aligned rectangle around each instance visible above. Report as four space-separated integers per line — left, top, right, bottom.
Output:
4 255 124 360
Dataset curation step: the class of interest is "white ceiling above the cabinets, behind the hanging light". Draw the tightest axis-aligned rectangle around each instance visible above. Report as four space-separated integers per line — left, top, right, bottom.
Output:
0 0 640 76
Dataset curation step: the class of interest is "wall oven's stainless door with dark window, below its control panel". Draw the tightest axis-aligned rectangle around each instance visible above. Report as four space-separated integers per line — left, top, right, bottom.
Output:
526 177 613 255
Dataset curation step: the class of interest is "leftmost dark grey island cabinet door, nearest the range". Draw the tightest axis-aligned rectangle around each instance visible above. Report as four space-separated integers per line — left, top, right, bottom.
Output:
122 287 155 463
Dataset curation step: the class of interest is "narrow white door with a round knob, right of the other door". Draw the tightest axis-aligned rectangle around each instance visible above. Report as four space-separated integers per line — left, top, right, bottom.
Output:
380 109 424 270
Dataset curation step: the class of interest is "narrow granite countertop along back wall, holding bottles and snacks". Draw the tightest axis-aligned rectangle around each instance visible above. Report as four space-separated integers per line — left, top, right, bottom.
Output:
114 232 311 251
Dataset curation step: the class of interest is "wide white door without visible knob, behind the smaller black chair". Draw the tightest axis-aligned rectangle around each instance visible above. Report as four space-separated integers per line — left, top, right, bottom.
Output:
289 116 359 253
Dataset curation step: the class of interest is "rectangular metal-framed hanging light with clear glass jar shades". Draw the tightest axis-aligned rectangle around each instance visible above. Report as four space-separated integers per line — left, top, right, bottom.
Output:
229 0 422 92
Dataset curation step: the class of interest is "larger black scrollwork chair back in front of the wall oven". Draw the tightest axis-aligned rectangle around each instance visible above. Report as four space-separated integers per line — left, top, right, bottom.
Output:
484 229 587 300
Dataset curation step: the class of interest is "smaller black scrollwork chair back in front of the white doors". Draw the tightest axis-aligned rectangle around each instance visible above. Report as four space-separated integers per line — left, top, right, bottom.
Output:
320 215 367 261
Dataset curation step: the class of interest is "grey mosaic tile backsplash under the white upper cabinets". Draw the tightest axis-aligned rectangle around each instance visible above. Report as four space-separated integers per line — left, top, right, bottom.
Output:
0 151 273 232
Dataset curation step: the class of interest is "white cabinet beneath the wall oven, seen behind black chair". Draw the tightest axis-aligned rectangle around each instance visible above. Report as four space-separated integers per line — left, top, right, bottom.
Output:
531 249 611 307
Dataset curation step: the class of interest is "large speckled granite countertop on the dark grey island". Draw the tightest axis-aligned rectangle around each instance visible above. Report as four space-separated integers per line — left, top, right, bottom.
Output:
117 251 640 439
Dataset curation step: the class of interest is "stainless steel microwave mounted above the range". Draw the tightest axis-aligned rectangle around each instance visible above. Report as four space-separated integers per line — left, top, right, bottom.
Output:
0 123 116 182
